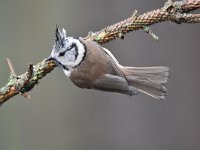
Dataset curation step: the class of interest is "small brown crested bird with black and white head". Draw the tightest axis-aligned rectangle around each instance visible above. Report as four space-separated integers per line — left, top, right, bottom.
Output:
46 26 169 100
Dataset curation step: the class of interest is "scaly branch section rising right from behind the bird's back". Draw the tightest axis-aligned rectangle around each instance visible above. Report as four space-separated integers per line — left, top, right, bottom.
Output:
84 0 200 44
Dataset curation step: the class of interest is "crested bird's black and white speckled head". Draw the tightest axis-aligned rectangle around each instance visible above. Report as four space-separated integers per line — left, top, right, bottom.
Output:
51 27 86 70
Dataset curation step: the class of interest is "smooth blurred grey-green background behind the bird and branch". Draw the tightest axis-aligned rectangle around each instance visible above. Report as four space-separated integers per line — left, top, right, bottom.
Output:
0 0 200 150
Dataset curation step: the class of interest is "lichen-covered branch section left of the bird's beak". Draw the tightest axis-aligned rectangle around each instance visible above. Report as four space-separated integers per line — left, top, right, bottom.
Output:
0 60 56 104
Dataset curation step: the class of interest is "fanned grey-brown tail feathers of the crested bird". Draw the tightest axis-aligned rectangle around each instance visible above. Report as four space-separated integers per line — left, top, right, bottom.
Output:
122 66 169 100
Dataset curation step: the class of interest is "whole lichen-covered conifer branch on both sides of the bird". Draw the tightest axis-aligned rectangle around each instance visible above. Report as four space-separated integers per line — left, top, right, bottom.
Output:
0 0 200 104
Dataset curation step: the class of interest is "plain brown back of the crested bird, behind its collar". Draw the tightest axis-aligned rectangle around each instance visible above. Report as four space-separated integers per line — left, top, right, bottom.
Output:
70 40 124 87
